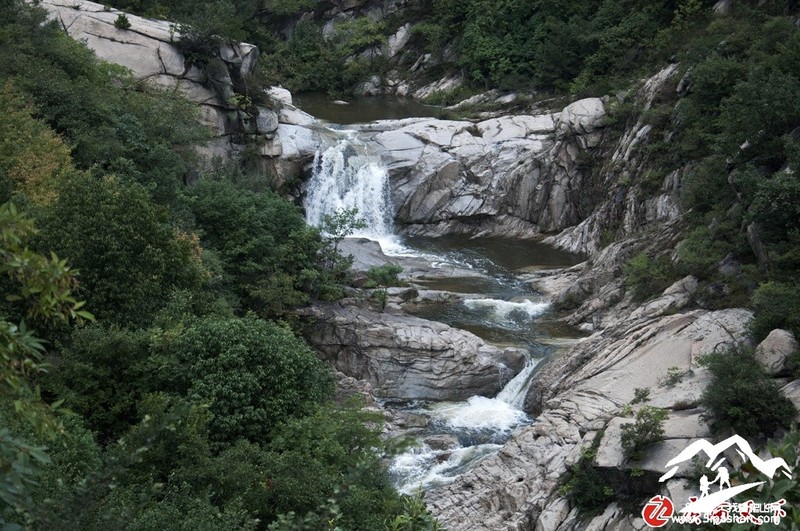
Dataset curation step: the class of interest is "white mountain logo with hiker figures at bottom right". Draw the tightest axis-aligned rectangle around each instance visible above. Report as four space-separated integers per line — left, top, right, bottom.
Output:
659 435 792 514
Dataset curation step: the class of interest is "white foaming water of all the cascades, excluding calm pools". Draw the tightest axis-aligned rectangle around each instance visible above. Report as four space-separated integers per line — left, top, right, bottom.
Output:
306 135 547 492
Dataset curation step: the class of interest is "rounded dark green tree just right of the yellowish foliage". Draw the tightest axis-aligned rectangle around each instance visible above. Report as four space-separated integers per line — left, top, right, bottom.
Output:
39 174 204 324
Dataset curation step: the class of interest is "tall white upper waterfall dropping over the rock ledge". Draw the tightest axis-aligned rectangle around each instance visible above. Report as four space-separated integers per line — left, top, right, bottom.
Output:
306 136 394 242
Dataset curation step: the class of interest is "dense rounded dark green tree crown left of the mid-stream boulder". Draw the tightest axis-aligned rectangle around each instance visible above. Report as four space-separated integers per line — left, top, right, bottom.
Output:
158 317 333 443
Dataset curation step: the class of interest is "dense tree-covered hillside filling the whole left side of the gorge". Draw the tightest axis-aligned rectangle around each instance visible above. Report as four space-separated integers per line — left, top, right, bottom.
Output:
0 0 433 530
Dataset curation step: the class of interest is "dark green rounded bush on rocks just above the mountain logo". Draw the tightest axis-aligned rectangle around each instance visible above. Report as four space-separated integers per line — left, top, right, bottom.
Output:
701 346 797 437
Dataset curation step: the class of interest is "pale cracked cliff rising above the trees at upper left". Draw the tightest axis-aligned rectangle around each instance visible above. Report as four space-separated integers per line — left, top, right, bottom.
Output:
40 0 278 164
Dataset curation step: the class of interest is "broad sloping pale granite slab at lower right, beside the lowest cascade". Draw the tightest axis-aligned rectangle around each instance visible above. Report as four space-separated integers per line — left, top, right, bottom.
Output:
427 310 750 531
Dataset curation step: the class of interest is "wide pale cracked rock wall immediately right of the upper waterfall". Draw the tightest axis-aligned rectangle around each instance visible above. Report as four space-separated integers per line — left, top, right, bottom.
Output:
360 99 605 237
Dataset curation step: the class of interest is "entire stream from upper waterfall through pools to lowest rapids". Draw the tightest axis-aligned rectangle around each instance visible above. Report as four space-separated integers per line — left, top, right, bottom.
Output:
306 136 579 493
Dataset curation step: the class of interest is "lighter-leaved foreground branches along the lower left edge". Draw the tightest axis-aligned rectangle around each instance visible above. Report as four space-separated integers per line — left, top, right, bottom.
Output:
0 203 93 527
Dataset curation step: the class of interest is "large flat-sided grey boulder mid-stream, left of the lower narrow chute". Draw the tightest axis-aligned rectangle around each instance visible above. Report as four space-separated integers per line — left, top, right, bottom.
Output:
308 304 519 401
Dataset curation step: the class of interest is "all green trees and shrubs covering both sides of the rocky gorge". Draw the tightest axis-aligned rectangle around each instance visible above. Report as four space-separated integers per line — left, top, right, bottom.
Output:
0 0 800 530
